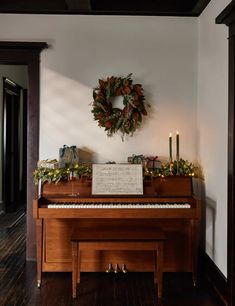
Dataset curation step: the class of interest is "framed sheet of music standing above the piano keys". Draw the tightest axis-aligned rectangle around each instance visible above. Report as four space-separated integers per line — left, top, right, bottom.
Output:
92 164 143 195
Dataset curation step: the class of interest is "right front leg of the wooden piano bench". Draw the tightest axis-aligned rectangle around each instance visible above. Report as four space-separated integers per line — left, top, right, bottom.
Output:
154 242 163 299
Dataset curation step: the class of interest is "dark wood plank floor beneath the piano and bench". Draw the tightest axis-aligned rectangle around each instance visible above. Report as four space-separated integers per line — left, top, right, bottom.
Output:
0 218 223 306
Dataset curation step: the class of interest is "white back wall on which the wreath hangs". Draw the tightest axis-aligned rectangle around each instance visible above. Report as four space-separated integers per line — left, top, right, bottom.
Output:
0 15 197 162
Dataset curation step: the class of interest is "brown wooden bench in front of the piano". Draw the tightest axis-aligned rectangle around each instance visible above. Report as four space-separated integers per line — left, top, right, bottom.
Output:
71 227 166 299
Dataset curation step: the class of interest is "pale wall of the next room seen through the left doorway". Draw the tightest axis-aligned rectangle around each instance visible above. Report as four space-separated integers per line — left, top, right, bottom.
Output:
0 65 28 207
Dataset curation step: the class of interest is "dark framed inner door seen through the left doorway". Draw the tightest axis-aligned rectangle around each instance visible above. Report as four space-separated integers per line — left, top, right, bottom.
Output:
2 77 27 213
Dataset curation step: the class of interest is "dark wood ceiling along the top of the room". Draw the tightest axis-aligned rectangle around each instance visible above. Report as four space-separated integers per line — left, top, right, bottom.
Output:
0 0 210 16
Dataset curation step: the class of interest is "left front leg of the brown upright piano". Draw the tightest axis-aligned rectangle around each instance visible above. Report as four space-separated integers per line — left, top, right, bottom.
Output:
36 219 43 288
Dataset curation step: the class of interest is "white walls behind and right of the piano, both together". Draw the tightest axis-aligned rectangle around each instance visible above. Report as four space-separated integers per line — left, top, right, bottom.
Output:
0 11 229 275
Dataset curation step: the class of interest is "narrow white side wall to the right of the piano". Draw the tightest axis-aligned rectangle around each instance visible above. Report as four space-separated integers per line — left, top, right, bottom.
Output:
197 0 230 276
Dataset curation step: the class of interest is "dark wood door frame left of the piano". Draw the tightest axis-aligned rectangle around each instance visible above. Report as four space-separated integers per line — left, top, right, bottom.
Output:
0 41 48 260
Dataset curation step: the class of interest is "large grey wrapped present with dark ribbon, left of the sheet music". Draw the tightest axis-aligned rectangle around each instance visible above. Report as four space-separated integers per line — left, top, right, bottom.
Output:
59 145 79 167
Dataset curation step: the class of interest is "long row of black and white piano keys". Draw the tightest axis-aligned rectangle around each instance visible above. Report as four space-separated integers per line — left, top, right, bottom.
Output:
47 202 191 209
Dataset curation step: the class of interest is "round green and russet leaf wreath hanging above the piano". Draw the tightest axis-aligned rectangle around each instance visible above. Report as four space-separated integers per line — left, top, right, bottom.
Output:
91 74 149 137
